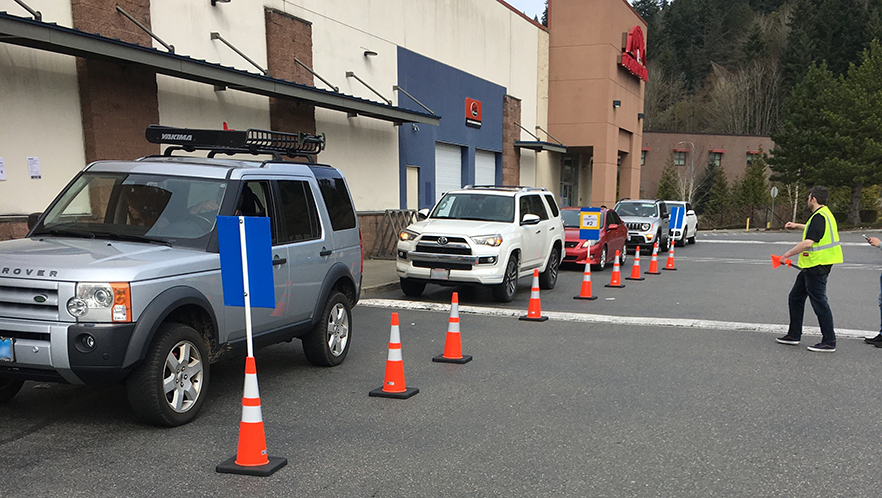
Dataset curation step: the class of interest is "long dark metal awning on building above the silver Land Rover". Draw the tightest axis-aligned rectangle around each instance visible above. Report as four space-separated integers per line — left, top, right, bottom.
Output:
0 11 441 126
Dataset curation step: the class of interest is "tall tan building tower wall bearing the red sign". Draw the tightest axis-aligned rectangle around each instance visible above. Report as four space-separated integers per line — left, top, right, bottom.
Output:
548 0 652 206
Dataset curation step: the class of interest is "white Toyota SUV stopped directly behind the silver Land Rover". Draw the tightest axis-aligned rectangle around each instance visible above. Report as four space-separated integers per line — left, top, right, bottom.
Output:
397 186 565 302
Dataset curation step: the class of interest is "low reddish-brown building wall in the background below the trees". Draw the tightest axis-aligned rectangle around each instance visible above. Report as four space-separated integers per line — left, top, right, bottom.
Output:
633 131 775 198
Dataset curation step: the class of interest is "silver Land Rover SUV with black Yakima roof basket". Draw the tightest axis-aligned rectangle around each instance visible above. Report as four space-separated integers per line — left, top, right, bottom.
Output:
0 126 362 426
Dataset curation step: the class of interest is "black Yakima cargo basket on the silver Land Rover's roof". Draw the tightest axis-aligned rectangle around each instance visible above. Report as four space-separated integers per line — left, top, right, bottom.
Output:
145 125 325 160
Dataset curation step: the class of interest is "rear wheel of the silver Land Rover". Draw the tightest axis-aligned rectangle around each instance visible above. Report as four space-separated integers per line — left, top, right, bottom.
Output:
301 291 352 367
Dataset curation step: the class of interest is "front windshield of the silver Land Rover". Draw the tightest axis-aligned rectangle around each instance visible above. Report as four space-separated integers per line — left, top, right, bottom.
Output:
34 173 227 249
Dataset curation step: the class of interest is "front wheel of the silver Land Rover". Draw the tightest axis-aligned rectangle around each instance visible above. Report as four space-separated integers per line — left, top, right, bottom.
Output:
126 323 210 427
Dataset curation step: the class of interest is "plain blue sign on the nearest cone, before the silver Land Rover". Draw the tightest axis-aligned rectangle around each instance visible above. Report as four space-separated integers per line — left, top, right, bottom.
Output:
217 216 276 308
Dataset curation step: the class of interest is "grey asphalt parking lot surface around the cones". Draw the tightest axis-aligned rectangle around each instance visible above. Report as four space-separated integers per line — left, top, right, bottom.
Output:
0 233 882 497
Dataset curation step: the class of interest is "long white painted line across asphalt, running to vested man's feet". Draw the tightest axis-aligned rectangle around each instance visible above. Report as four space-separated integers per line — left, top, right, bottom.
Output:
358 299 879 338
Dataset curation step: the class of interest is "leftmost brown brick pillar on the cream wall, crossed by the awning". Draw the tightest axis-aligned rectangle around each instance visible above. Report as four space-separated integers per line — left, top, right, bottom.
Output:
71 0 159 162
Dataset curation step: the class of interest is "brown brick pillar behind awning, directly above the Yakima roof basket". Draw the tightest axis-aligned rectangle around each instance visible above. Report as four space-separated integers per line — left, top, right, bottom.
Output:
265 9 315 133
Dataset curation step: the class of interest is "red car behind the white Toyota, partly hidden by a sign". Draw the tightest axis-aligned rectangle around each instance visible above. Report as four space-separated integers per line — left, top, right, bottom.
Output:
560 207 628 270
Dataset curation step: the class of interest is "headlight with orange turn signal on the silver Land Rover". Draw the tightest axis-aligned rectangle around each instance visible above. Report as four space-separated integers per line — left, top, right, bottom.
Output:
67 282 132 323
